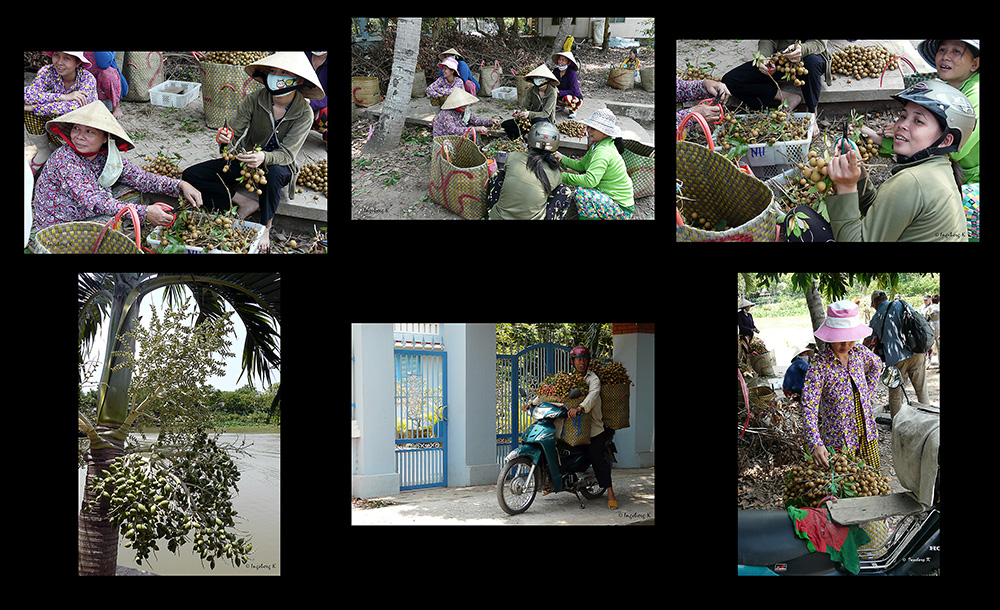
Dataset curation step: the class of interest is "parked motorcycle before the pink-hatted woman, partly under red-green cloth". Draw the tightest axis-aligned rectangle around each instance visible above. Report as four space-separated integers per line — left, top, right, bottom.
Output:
737 380 941 576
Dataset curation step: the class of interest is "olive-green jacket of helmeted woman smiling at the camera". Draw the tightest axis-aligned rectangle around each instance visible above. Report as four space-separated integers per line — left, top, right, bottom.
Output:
826 155 969 241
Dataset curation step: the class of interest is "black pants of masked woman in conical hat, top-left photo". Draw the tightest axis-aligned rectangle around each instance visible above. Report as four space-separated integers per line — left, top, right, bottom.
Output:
181 159 292 226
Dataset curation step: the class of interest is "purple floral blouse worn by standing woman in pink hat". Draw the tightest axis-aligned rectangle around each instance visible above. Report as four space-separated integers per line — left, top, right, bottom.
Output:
802 344 882 451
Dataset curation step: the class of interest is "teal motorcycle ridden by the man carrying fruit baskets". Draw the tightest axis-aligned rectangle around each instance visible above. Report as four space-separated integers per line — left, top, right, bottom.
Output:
497 389 616 515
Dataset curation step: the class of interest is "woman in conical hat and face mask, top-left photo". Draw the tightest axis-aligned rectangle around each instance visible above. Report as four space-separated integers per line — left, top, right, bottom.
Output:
183 51 326 252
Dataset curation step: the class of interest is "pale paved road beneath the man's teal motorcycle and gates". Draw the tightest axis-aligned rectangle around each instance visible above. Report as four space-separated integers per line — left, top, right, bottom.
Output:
351 468 655 525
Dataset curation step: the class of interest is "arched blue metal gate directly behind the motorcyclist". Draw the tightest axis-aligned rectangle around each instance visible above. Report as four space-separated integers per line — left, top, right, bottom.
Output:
497 343 572 464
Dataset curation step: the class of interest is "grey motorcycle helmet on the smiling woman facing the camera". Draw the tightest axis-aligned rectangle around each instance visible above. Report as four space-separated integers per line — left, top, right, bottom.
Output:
892 79 976 163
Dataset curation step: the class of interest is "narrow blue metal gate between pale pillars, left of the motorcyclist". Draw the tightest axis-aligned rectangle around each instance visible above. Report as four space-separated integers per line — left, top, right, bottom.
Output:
394 349 448 490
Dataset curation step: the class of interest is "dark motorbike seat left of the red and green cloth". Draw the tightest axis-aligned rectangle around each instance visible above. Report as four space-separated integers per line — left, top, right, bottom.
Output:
736 510 809 566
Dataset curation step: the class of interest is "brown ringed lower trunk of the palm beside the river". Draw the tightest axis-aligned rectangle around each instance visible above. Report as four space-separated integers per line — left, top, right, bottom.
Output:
77 426 125 576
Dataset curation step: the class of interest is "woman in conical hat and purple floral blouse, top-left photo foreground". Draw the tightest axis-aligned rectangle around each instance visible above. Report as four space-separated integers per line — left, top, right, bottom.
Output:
33 101 201 230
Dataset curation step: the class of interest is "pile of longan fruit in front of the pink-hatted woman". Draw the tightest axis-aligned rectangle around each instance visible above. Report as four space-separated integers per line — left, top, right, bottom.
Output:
782 451 889 508
